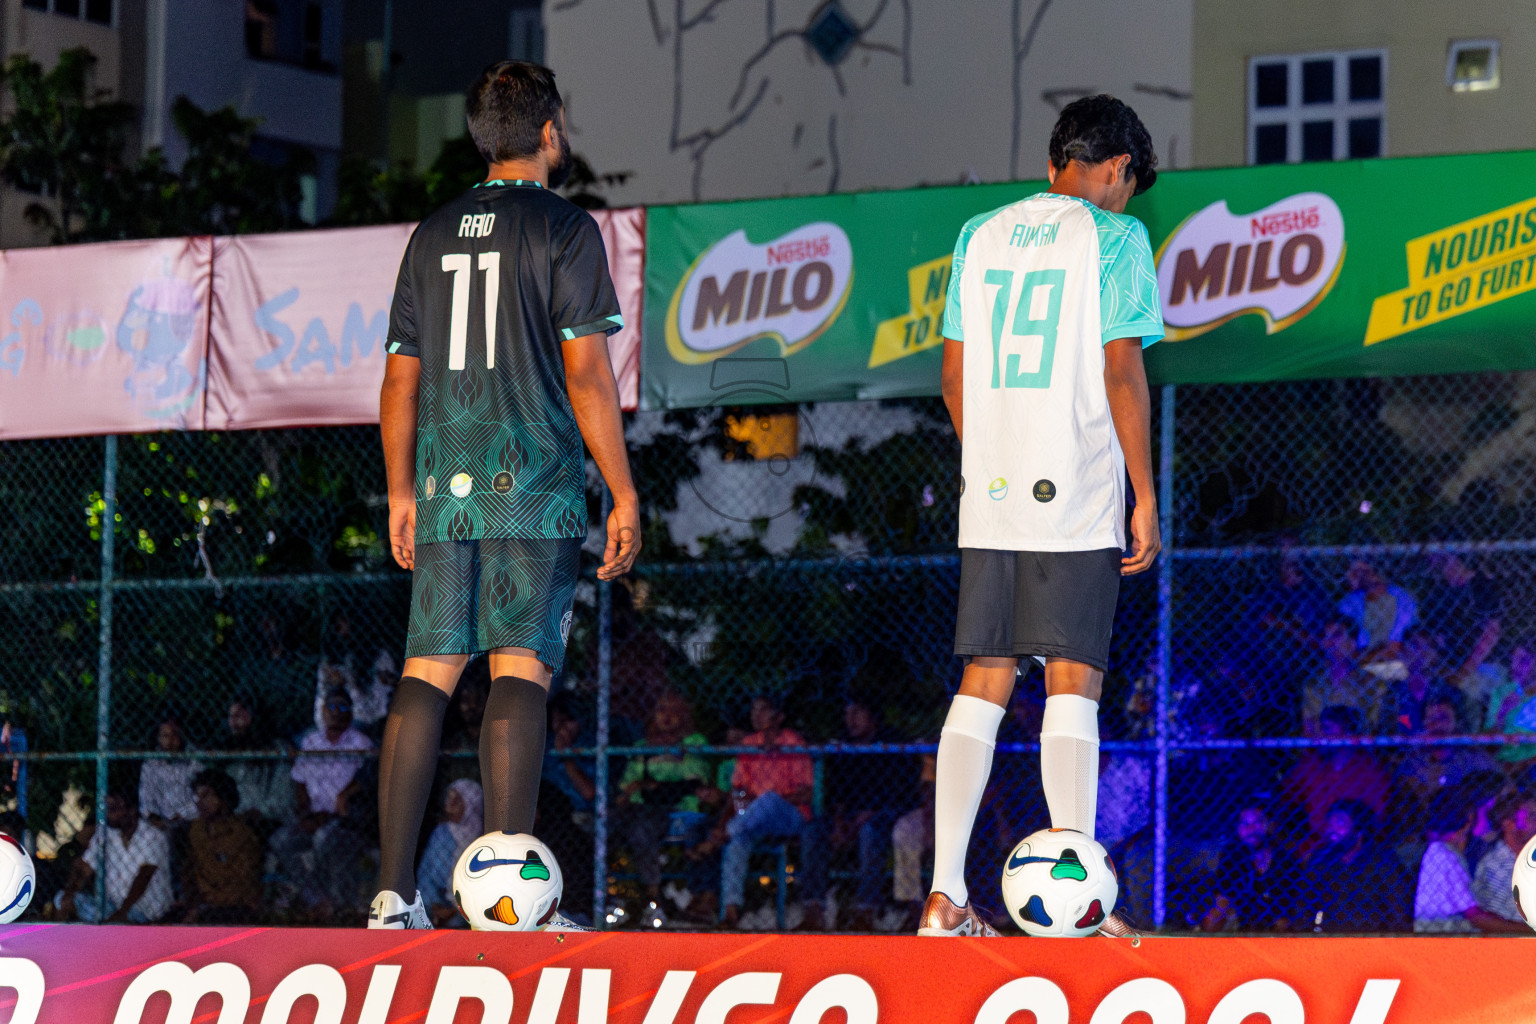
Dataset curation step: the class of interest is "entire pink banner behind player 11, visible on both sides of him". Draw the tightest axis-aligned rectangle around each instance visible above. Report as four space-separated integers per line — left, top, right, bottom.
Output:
0 209 645 441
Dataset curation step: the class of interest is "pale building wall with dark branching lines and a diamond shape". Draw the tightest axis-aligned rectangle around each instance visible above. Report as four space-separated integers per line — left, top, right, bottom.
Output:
544 0 1195 204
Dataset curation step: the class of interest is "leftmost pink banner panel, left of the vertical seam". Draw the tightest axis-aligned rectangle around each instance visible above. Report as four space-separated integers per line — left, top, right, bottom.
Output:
0 236 212 439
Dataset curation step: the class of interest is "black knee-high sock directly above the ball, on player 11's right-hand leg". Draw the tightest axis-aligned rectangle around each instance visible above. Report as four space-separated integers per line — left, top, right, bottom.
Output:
481 676 550 832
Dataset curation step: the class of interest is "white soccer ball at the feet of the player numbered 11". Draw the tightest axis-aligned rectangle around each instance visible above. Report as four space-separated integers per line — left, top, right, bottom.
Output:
453 832 564 932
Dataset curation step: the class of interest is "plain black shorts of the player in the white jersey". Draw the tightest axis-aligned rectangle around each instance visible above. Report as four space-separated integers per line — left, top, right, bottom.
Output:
955 548 1121 671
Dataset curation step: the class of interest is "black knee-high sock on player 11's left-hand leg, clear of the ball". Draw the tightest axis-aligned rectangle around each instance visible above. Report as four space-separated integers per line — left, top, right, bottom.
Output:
379 676 449 901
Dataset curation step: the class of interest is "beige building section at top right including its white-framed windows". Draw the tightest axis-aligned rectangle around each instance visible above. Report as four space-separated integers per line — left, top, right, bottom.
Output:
1193 0 1536 167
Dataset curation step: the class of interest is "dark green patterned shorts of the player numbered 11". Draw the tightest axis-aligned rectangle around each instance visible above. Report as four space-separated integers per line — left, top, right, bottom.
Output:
406 539 582 672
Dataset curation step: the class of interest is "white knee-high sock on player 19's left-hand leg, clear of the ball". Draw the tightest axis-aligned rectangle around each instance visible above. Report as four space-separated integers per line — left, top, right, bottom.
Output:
932 695 1003 906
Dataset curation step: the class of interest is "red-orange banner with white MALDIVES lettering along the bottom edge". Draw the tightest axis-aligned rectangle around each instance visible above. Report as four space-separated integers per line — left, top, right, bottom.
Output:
0 926 1536 1024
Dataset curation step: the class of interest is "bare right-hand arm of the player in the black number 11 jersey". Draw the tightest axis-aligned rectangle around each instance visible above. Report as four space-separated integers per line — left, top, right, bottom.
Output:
565 335 641 580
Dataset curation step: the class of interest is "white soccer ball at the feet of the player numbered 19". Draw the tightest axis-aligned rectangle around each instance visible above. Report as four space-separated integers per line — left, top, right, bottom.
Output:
1003 829 1120 938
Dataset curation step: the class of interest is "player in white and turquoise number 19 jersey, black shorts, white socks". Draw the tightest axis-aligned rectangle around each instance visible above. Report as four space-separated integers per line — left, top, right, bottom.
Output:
917 95 1163 935
